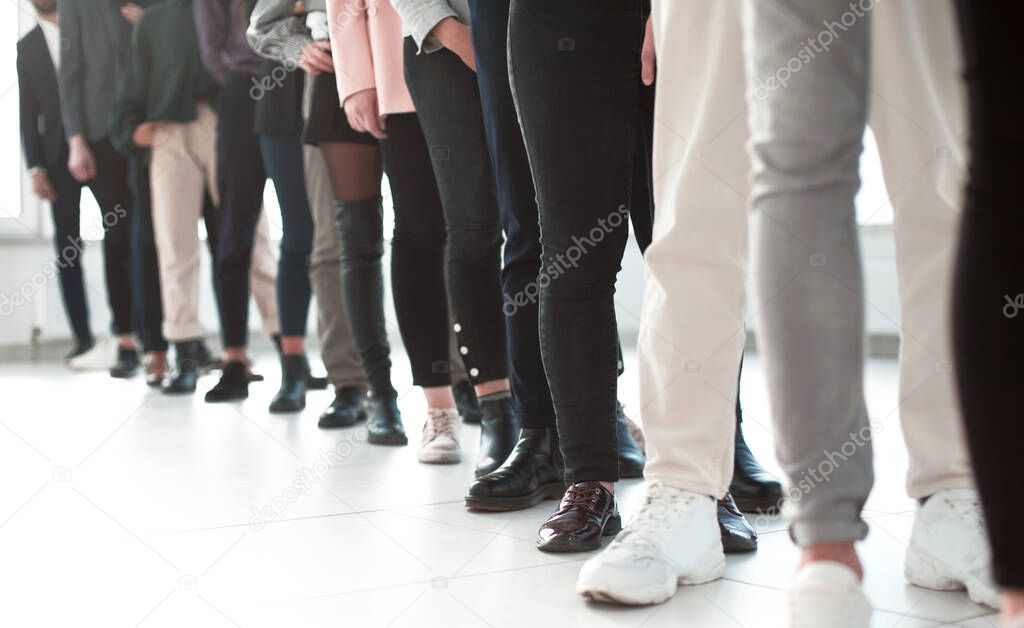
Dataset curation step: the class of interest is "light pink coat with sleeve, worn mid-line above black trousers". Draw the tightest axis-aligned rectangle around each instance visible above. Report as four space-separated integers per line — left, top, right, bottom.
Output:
327 0 416 115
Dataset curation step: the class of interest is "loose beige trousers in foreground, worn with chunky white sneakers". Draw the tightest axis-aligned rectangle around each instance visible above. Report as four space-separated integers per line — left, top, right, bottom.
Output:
639 0 972 498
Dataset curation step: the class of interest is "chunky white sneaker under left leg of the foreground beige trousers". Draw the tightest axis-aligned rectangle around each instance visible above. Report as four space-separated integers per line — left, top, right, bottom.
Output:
577 482 725 604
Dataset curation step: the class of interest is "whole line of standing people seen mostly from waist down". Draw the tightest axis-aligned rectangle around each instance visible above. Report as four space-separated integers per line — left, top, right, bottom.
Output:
18 0 1024 626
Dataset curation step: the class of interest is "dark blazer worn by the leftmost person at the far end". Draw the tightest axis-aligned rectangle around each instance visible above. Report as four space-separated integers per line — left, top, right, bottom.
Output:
17 26 68 169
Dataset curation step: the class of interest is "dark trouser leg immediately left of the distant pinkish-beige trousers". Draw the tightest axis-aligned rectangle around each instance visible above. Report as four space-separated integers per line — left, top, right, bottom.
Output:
128 156 167 351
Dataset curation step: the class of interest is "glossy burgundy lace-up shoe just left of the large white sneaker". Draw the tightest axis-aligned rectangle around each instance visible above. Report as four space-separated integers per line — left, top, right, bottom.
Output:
537 482 623 552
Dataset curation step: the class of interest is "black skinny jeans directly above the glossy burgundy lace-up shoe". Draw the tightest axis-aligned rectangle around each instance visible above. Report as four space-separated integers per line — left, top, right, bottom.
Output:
509 0 650 482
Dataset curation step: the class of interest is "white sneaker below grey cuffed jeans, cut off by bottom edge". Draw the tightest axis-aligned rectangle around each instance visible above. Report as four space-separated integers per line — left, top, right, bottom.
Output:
790 560 871 628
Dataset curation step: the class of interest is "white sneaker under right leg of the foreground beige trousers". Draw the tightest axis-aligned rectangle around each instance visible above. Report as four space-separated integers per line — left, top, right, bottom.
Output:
904 489 999 609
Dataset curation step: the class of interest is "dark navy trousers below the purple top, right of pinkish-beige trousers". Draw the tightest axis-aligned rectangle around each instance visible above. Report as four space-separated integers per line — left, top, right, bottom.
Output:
215 73 266 347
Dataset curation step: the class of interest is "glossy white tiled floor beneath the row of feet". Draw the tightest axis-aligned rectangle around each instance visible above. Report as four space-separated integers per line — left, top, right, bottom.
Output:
0 355 995 628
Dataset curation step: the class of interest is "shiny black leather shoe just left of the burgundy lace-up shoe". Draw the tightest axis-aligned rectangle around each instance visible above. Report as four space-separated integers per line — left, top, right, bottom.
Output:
466 427 564 511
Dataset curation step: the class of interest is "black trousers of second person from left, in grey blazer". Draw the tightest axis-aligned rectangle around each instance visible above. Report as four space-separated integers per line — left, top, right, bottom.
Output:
85 138 134 334
